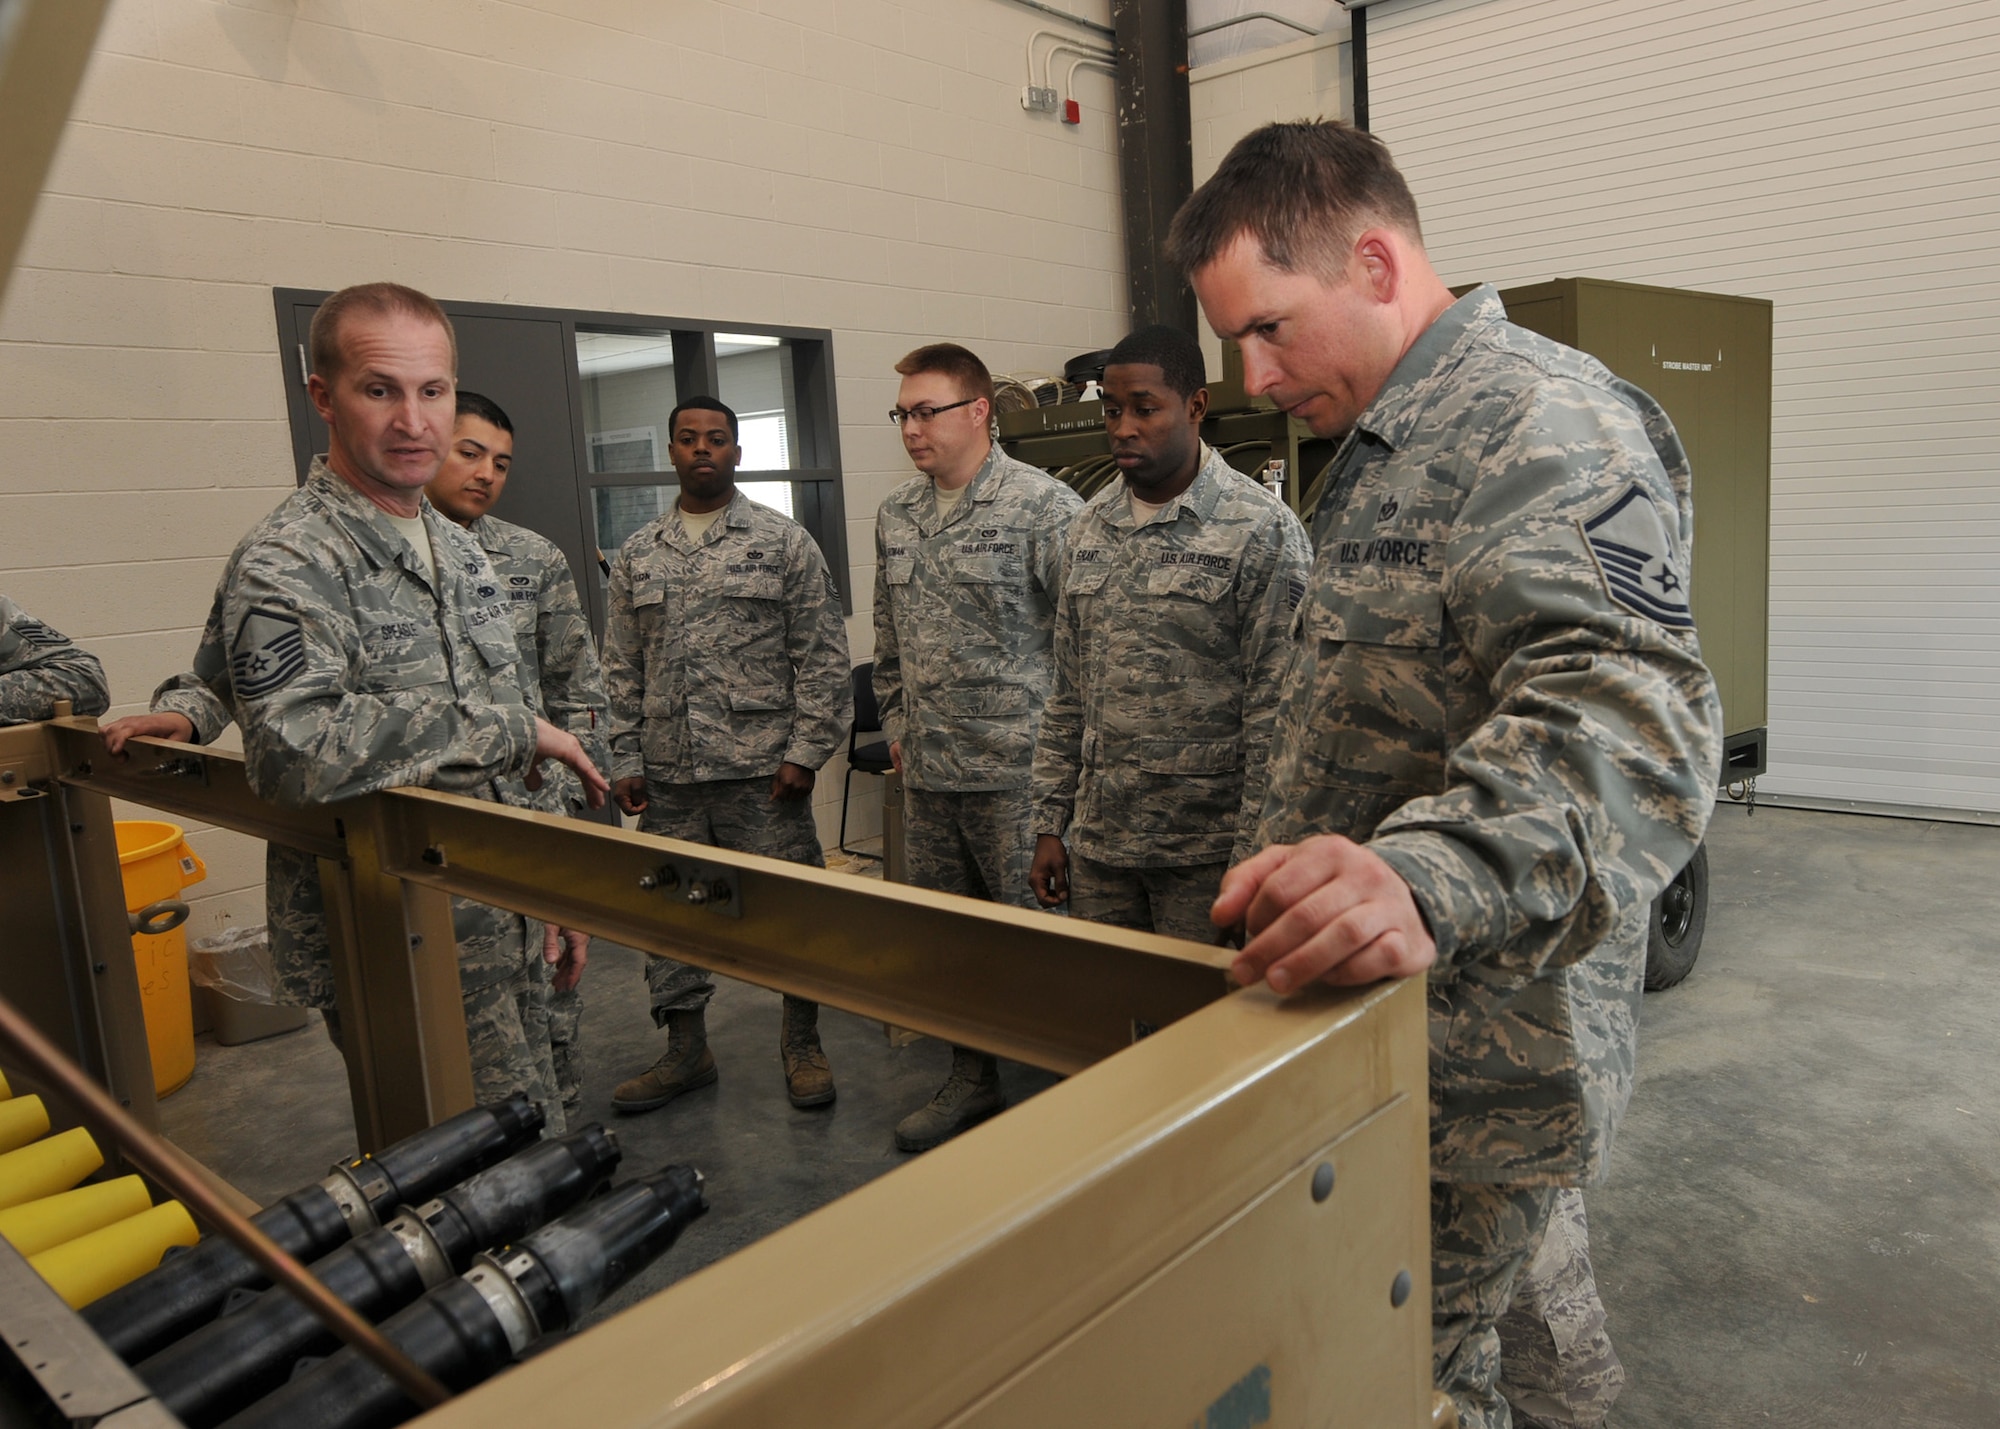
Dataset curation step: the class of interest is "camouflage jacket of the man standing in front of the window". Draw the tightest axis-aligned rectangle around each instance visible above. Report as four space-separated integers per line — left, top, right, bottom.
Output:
604 492 854 785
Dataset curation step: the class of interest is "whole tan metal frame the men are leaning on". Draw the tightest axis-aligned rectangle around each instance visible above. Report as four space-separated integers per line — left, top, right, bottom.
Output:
0 721 1432 1427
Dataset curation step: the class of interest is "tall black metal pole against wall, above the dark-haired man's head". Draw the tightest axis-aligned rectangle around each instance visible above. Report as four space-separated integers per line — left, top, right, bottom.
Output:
1112 0 1196 332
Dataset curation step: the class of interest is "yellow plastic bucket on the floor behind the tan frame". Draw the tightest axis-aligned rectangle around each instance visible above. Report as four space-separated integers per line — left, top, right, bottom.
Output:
116 819 208 1097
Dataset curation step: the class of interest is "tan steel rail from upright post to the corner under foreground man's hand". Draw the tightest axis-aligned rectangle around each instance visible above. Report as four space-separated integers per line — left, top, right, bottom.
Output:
368 789 1230 1073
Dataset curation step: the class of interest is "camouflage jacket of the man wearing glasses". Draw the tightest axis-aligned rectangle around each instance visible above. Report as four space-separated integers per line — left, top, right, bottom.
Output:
874 446 1082 793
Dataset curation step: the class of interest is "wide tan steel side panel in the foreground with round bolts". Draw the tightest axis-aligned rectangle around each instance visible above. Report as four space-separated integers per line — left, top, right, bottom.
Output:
420 981 1432 1429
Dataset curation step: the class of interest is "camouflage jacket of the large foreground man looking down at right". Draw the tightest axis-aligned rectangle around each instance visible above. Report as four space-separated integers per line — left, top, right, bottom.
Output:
1260 288 1722 1185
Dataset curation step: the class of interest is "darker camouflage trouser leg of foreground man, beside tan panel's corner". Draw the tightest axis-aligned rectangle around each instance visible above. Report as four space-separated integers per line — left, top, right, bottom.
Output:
1430 1181 1558 1429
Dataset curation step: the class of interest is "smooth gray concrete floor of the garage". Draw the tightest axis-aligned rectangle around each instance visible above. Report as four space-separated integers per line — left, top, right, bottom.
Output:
162 807 2000 1429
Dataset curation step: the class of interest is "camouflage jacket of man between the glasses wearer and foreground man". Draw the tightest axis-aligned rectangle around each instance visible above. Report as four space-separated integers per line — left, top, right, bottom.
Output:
1034 446 1312 867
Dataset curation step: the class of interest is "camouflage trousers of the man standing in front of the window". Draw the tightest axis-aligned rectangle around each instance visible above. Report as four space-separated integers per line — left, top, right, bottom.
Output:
638 777 826 1027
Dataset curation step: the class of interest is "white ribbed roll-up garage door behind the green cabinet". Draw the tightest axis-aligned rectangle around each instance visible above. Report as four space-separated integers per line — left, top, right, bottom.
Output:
1368 0 2000 817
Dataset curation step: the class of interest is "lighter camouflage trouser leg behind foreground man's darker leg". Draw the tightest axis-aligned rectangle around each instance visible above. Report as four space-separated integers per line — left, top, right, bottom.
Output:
1500 1187 1626 1429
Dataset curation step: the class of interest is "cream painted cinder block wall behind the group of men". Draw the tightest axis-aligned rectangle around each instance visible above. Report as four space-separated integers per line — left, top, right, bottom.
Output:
0 0 1126 935
